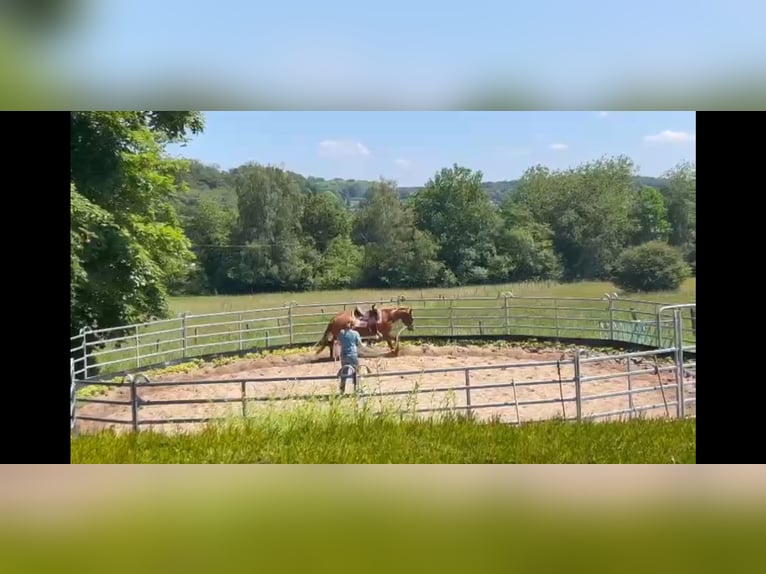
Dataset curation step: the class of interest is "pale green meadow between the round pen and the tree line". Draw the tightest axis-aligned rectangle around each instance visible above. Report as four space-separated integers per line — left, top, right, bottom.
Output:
73 279 696 374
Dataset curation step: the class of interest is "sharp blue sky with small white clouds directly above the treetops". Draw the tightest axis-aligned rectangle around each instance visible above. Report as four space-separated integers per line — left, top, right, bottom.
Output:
168 111 696 186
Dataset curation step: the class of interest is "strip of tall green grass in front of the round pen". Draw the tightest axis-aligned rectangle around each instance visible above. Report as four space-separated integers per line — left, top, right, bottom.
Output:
71 403 696 464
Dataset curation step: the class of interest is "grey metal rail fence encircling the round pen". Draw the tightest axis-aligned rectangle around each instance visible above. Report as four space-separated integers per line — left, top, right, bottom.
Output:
70 294 696 430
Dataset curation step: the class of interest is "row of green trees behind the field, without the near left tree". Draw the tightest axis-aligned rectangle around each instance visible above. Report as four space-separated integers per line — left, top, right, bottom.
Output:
179 156 696 294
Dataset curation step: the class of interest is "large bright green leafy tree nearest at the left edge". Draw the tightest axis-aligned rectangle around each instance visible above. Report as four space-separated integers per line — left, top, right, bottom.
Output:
70 112 203 335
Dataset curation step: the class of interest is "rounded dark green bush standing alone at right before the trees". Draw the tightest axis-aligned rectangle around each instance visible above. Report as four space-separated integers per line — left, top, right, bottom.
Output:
612 241 691 292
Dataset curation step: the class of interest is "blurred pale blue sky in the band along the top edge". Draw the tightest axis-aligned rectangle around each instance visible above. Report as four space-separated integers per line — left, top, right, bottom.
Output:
49 0 766 107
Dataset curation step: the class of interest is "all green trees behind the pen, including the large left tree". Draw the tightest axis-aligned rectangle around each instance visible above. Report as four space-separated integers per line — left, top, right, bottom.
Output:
70 112 696 342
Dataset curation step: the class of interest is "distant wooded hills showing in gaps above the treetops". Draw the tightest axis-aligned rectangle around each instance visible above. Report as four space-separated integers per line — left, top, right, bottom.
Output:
177 161 666 215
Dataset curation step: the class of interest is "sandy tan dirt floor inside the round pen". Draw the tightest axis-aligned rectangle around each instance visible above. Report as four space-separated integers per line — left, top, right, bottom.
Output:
78 345 696 432
